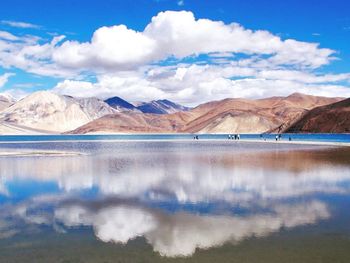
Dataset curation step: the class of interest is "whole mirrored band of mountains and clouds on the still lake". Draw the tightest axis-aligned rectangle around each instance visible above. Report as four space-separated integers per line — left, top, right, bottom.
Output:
0 145 350 256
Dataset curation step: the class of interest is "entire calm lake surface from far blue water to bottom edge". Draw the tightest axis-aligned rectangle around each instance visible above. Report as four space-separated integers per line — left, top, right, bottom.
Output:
0 135 350 263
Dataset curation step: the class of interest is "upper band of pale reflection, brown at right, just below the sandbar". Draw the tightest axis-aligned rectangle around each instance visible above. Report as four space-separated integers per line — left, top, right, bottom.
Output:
0 148 350 204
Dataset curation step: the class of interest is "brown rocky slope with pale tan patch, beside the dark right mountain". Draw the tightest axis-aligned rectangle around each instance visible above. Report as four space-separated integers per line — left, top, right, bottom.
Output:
182 93 340 133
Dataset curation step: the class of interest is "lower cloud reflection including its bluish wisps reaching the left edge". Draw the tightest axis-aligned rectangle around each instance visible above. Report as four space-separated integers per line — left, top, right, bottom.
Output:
0 196 330 257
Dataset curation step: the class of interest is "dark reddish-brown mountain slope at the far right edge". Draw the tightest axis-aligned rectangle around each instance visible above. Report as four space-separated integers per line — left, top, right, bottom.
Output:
287 98 350 133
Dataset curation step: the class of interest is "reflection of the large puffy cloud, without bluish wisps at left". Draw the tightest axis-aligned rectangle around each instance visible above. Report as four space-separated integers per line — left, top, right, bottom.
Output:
55 201 330 257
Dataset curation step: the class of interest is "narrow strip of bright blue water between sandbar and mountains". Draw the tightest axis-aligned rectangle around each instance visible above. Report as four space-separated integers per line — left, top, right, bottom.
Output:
0 133 350 142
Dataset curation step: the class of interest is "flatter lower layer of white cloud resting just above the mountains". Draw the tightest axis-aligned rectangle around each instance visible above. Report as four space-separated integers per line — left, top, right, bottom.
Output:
54 65 350 106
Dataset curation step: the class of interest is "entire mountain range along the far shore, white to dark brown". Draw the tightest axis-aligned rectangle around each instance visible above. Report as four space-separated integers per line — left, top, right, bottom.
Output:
0 91 350 134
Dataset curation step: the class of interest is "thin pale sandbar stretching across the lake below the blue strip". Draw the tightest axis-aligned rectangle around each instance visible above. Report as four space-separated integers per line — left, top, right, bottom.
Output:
0 139 350 147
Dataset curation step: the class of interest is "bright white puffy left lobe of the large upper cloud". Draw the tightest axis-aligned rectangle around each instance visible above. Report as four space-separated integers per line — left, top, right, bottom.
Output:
53 25 157 69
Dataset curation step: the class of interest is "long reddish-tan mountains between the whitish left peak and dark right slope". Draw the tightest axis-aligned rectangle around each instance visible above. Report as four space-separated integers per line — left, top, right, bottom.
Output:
71 93 341 133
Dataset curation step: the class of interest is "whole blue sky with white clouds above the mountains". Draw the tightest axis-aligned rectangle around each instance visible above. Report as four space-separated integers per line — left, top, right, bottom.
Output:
0 0 350 106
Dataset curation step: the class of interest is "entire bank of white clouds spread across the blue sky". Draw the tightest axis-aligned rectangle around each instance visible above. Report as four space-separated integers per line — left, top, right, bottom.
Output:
0 11 350 102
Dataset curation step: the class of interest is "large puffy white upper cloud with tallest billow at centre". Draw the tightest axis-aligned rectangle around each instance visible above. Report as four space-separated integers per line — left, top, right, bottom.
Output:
53 11 334 70
